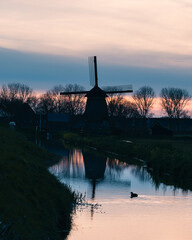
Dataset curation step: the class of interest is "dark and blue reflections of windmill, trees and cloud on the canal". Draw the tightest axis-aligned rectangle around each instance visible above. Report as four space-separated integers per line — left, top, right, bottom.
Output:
49 146 191 200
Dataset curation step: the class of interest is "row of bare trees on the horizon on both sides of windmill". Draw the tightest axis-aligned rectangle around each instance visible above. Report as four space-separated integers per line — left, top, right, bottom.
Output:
0 83 191 118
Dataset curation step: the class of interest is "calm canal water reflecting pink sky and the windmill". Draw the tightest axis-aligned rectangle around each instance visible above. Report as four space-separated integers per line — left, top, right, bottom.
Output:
49 143 192 240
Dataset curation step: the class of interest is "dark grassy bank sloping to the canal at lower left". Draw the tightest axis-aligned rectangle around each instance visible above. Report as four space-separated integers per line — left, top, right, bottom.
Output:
0 127 73 240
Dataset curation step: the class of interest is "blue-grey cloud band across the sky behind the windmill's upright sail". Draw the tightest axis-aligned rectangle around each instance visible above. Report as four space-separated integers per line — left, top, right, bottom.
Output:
0 48 192 94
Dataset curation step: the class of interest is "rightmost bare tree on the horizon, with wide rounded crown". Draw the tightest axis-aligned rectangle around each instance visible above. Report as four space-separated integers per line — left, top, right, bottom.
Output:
160 88 191 118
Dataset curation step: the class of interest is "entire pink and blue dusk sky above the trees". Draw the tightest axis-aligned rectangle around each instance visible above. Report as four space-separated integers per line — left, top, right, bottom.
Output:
0 0 192 95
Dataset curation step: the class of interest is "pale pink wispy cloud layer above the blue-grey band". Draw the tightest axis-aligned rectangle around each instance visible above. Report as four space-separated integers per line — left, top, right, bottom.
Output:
0 0 192 68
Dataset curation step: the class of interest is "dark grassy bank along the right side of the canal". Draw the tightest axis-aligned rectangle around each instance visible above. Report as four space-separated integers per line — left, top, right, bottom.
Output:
64 133 192 189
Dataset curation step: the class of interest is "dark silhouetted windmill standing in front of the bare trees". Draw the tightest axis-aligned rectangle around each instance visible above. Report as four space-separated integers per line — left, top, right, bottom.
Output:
60 56 133 123
